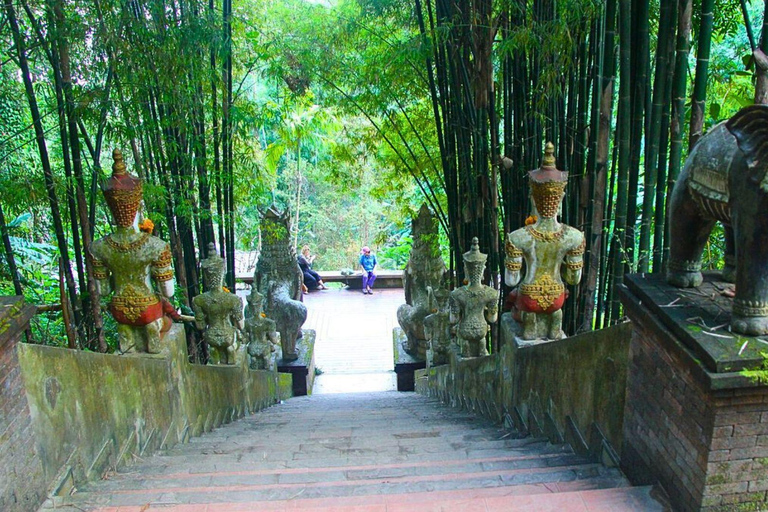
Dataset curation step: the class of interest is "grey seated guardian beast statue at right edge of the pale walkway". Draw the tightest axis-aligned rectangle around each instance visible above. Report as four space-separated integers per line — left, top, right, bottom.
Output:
397 204 445 359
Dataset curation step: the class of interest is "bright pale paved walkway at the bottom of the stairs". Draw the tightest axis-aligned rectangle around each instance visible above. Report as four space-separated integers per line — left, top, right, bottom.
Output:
304 288 405 394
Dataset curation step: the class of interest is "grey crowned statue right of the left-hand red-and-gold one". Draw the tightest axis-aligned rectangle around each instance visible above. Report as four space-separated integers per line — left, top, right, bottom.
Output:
192 243 243 364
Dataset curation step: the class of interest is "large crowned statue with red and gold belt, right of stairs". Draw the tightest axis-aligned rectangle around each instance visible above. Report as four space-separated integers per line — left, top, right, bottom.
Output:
504 142 585 340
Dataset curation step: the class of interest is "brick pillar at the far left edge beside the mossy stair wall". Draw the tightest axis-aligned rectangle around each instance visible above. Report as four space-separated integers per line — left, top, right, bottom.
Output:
0 300 45 511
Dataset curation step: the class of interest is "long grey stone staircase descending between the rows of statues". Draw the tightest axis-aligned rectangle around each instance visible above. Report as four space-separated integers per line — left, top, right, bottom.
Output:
48 392 667 512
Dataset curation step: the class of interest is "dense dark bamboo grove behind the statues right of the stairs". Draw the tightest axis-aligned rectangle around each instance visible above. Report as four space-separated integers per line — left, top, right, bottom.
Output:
415 0 766 340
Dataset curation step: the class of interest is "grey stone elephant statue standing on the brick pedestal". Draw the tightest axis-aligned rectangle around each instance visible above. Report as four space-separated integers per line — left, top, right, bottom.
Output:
667 105 768 336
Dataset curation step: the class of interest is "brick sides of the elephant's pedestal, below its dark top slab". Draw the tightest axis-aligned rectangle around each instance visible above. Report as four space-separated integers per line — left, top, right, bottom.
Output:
622 286 768 511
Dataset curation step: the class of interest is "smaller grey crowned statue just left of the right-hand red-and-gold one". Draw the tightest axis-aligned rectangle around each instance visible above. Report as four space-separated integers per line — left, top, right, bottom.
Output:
449 237 499 357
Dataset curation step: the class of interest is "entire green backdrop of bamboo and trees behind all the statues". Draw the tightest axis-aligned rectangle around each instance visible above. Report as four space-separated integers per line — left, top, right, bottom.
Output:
0 0 768 350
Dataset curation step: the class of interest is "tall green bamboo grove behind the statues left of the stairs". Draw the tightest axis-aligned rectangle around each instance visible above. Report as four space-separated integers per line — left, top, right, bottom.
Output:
0 0 235 358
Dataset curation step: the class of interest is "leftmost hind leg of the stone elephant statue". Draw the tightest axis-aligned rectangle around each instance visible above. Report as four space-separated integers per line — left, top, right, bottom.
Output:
667 177 715 288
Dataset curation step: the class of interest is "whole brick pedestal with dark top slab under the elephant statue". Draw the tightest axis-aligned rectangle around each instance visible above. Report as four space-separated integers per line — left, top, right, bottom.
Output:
621 275 768 511
